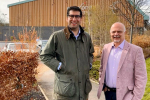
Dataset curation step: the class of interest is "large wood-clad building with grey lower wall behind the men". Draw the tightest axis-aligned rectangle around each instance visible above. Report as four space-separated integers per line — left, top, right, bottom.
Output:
0 0 149 39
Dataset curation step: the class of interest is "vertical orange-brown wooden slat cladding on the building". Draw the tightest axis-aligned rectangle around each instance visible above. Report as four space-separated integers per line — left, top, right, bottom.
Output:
9 0 144 27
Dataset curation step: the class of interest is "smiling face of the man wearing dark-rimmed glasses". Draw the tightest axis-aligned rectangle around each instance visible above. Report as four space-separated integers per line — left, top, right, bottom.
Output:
67 10 82 30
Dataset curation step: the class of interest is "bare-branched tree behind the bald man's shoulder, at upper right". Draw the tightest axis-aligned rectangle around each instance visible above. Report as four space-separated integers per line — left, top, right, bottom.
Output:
110 0 150 43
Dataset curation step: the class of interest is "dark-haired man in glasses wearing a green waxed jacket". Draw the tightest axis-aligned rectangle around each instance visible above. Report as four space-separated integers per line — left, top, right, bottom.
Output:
40 6 94 100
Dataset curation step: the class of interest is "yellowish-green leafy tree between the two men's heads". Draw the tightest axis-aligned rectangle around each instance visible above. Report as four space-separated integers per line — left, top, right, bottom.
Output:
85 5 118 48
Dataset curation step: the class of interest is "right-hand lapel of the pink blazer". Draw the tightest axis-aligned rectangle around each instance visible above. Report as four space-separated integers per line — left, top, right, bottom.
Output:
117 41 129 73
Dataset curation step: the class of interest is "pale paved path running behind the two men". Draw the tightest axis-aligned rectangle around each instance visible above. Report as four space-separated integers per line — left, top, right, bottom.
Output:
36 62 105 100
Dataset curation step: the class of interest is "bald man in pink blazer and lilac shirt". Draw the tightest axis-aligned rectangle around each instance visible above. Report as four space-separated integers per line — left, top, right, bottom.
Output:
97 22 147 100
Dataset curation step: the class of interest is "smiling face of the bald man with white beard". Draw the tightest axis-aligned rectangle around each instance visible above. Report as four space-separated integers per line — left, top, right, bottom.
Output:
110 23 125 44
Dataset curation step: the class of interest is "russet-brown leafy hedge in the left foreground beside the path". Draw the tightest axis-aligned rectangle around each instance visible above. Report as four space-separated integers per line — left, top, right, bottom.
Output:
0 51 39 100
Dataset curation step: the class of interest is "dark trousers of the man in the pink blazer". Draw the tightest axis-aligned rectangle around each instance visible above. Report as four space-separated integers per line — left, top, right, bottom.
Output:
103 84 116 100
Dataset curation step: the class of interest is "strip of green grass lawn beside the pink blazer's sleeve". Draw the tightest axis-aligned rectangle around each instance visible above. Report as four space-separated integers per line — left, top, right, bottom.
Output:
142 58 150 100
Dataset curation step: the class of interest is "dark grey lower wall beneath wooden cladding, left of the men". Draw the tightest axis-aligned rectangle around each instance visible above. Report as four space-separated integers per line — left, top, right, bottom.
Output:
0 26 64 41
